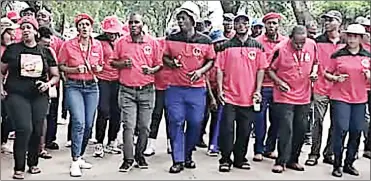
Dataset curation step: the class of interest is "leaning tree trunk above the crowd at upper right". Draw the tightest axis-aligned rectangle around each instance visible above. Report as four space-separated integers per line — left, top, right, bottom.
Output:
291 1 314 25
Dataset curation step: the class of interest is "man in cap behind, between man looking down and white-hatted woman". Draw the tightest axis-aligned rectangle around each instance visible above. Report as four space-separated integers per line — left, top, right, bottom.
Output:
305 10 344 166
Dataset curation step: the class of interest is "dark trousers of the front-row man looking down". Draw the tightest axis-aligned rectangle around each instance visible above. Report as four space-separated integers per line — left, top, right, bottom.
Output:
275 103 310 165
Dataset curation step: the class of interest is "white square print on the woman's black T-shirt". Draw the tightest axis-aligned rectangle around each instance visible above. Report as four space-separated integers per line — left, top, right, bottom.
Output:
21 54 44 78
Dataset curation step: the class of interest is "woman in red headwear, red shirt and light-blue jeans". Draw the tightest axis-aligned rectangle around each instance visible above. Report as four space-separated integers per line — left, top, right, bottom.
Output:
58 13 103 177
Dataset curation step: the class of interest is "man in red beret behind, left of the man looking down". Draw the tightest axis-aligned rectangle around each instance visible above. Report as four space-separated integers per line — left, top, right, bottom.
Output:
253 13 287 161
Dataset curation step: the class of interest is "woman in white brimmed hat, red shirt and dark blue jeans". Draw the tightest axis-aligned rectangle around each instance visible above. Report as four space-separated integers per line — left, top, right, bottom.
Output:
325 24 371 177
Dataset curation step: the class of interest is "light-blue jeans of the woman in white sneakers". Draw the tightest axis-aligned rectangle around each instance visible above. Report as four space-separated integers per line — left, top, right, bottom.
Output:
64 80 99 158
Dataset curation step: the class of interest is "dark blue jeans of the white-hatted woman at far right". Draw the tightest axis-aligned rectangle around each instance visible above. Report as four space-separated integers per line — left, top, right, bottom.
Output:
332 100 366 168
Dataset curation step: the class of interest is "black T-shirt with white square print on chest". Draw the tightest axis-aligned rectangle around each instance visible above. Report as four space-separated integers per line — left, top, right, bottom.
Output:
1 42 57 95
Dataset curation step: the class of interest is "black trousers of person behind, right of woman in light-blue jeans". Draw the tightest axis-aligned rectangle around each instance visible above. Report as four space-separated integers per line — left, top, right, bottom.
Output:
95 80 120 144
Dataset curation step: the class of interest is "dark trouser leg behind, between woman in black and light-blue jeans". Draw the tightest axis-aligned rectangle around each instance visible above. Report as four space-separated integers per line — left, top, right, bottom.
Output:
45 87 60 144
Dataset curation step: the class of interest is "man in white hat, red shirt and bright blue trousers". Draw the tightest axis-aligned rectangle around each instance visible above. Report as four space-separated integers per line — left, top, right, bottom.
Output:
164 1 216 173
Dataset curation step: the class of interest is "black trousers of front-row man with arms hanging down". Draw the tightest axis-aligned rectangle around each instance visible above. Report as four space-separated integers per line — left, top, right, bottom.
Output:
219 104 254 163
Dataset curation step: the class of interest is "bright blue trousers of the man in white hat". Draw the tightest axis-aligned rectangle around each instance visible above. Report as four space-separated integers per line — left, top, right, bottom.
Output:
165 86 206 163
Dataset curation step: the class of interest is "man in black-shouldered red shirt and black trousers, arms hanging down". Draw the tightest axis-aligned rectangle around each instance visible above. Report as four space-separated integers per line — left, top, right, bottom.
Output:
217 14 268 172
